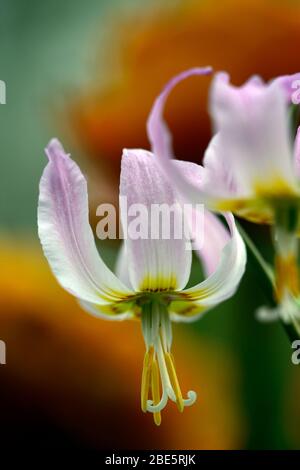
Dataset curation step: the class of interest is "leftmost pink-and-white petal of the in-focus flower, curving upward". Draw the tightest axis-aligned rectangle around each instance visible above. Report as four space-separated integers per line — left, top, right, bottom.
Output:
38 139 132 304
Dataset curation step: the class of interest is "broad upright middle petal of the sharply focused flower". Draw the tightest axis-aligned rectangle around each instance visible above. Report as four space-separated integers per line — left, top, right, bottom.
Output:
120 149 191 291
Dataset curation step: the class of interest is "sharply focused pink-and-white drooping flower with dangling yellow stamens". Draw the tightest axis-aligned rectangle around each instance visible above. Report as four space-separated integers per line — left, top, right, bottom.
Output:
38 134 246 425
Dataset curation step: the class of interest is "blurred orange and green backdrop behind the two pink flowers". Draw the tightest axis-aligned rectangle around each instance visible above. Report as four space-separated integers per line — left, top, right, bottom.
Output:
0 0 300 449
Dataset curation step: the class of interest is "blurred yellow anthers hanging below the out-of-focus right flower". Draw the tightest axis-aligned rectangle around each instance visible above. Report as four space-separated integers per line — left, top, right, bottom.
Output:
275 255 299 301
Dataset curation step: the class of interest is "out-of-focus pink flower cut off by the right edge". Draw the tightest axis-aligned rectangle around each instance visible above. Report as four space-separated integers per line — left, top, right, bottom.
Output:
148 68 300 333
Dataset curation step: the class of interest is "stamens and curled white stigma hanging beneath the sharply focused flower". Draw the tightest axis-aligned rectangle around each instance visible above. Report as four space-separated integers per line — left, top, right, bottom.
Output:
141 297 197 426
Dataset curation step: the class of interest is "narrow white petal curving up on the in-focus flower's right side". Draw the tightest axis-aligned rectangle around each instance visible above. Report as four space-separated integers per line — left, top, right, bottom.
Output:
170 214 246 321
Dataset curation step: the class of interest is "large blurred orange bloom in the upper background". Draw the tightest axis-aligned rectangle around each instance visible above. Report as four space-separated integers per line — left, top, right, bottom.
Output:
69 0 300 195
